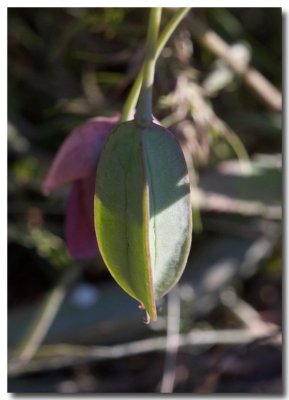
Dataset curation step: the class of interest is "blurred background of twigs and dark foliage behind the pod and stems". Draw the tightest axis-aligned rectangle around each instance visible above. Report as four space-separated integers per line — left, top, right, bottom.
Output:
8 8 282 394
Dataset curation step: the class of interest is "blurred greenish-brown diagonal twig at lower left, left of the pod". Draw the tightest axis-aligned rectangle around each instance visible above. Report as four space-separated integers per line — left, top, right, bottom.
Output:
9 265 81 371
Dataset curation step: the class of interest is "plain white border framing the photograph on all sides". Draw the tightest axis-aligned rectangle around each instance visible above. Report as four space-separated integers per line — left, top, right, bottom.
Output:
0 0 289 399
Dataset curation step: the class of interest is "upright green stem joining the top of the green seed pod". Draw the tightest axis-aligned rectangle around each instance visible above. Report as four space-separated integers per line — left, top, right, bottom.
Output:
135 7 162 126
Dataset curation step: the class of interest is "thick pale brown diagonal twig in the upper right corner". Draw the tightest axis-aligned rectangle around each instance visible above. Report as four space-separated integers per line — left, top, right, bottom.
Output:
189 17 282 112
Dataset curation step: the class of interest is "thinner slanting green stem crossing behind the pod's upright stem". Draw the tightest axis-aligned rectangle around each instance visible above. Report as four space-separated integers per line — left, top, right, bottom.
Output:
121 8 190 122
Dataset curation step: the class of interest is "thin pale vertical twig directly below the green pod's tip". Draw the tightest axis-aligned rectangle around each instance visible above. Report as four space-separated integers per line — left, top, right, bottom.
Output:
160 286 180 393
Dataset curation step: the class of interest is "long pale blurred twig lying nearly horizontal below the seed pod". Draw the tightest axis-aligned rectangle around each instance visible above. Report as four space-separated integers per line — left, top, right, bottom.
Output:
9 329 277 376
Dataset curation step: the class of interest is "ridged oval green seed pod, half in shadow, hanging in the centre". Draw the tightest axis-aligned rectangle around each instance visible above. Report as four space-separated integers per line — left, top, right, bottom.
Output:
95 121 192 320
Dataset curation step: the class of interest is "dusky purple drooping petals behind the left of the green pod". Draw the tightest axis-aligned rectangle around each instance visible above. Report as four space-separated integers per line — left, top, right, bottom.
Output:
42 114 120 259
